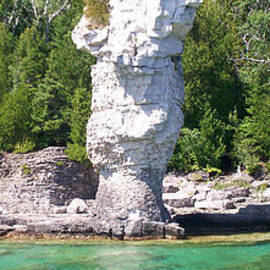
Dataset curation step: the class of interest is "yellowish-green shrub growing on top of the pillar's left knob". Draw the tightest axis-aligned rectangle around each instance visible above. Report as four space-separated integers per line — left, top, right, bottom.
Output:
84 0 110 25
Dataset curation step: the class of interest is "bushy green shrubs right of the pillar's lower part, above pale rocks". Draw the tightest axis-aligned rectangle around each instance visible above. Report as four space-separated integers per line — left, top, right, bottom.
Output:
168 106 226 173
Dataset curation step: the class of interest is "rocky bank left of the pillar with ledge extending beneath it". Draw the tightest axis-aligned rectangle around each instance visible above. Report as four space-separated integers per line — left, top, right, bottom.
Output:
0 147 184 239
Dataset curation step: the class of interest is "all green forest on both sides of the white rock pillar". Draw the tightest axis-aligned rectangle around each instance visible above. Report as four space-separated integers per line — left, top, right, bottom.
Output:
0 0 270 174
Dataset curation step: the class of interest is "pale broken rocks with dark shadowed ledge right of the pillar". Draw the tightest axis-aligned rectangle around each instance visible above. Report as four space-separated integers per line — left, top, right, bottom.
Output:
163 172 270 235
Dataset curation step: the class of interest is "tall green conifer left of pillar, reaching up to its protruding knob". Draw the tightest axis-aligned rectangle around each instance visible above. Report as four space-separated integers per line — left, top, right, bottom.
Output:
32 32 93 148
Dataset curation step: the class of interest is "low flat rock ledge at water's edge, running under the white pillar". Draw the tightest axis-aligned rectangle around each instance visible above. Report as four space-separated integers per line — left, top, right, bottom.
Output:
0 214 185 240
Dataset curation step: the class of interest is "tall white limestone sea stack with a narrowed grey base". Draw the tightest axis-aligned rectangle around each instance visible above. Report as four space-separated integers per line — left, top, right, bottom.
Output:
72 0 202 234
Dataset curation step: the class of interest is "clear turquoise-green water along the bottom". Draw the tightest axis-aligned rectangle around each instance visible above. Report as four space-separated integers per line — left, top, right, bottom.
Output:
0 240 270 270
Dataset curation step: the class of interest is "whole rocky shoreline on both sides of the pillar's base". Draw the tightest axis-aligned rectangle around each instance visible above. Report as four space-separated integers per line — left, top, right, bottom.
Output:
0 147 270 240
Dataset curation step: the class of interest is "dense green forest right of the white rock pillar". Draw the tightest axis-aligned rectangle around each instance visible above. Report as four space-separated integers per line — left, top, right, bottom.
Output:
169 0 270 174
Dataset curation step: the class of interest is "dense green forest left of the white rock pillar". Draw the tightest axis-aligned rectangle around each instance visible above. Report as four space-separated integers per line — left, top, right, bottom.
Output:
0 0 95 161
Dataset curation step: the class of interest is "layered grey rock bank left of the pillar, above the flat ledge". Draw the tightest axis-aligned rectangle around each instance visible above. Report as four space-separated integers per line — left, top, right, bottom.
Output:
0 147 98 215
